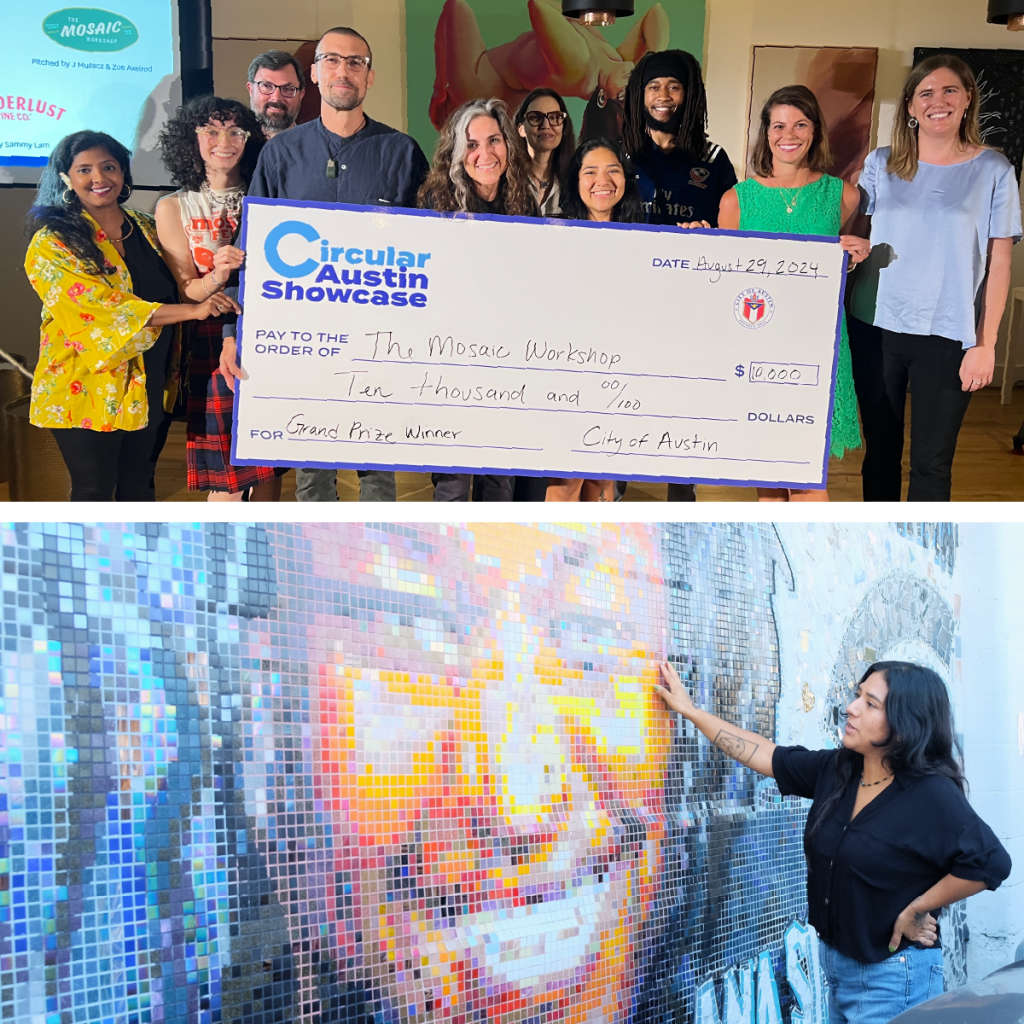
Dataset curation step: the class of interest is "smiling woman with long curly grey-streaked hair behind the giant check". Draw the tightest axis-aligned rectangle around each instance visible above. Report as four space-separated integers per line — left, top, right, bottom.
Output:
417 99 539 502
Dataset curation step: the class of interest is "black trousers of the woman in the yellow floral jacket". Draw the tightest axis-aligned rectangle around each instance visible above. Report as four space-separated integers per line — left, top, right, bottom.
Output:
53 404 170 502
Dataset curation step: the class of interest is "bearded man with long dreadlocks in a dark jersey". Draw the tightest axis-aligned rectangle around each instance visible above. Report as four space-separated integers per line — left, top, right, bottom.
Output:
623 50 736 227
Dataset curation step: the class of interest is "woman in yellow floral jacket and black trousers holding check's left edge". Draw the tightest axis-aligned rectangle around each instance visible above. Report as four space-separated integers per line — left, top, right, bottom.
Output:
25 131 238 501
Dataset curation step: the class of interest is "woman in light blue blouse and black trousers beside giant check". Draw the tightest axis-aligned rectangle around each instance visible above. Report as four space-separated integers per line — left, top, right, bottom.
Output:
849 53 1022 501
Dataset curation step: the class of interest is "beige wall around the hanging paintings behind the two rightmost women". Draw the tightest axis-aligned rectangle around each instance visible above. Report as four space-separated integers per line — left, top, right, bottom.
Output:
705 0 1024 384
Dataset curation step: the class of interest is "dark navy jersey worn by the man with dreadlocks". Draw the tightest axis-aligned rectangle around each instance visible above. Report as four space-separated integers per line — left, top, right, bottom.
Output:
633 145 736 227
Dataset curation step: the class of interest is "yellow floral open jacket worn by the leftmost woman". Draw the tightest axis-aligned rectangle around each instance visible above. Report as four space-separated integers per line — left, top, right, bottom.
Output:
25 209 180 431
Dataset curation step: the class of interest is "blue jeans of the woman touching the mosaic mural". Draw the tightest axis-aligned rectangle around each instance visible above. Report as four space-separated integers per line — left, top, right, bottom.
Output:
821 942 942 1024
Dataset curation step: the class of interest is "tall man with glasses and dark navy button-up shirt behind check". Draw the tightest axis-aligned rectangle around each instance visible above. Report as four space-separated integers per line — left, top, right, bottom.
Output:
235 28 428 502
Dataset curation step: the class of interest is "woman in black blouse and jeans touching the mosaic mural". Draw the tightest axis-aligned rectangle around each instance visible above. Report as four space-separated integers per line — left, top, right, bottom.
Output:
655 662 1010 1024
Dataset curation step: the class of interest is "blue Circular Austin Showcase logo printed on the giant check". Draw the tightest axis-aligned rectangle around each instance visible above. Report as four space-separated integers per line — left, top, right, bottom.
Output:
261 220 431 309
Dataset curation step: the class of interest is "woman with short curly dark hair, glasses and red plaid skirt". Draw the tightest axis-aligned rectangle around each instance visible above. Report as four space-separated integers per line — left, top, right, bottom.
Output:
157 96 281 501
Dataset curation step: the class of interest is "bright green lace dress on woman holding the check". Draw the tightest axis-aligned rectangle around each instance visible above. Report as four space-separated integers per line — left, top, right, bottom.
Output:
736 174 860 459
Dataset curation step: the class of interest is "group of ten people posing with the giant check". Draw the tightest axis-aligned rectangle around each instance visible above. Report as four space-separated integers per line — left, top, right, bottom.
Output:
19 28 1022 501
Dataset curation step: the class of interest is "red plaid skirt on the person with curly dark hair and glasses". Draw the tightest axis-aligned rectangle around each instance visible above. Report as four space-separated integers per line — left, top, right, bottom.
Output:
186 319 275 494
